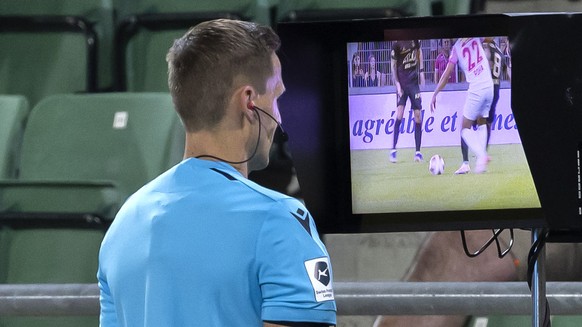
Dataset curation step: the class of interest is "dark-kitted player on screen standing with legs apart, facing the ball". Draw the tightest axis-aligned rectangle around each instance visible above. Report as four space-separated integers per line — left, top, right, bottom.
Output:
390 40 424 162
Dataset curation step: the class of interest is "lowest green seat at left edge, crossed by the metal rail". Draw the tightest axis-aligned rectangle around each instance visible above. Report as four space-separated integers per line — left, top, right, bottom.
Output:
0 226 105 327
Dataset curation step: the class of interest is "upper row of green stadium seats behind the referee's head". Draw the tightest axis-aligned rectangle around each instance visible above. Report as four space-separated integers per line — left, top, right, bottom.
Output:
0 0 479 105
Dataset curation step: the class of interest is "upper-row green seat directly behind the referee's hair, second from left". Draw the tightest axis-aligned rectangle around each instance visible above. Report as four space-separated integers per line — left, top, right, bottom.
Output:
115 0 269 92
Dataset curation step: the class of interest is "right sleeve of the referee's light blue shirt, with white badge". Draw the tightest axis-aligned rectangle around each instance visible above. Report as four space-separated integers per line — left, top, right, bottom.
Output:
256 200 336 324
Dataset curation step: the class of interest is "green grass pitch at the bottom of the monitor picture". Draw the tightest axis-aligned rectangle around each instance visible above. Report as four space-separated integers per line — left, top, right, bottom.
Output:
351 144 540 213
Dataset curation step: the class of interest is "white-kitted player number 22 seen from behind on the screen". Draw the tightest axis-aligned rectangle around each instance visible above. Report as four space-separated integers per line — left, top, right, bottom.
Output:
430 38 493 174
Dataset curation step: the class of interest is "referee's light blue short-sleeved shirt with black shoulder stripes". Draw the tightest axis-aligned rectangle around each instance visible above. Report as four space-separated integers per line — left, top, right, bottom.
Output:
98 158 336 327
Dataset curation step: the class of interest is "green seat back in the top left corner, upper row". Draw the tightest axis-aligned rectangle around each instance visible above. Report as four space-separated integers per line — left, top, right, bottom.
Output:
0 15 97 105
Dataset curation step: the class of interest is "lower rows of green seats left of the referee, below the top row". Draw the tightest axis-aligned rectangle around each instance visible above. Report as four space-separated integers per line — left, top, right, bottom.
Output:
0 92 184 327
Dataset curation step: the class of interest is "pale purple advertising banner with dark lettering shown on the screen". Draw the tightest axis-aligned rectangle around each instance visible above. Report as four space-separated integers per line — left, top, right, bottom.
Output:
349 89 521 150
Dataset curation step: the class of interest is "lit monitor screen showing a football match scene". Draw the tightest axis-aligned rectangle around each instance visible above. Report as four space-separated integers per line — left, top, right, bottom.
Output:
345 36 541 214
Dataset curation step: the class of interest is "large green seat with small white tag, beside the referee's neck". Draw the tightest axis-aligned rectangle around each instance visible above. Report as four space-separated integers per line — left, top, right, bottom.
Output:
0 93 184 220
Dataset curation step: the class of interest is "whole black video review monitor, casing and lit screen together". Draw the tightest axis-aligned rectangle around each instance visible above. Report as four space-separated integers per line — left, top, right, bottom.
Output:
278 14 582 233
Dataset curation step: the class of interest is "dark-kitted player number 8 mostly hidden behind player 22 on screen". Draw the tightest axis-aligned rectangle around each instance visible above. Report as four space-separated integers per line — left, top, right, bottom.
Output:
455 38 507 175
